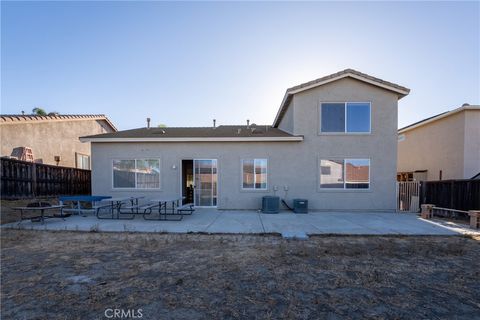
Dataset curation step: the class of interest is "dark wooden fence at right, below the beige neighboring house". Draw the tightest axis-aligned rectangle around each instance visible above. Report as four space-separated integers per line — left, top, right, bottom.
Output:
421 180 480 211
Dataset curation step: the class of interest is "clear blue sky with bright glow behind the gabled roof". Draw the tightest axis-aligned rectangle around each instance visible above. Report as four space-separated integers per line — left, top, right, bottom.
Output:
1 1 480 129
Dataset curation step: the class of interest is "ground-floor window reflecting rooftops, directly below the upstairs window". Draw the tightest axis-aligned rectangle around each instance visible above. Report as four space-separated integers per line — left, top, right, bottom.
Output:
320 159 370 189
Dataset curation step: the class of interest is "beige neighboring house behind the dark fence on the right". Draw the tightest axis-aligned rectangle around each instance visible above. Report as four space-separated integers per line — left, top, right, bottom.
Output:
398 104 480 181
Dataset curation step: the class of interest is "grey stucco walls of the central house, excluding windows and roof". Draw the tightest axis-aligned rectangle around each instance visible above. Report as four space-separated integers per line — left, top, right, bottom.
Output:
88 74 399 211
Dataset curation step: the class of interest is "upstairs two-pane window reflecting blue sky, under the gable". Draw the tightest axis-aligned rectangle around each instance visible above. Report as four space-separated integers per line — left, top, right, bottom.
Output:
320 102 370 133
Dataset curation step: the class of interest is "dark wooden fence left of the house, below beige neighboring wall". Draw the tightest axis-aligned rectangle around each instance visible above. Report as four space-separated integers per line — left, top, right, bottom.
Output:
0 158 91 199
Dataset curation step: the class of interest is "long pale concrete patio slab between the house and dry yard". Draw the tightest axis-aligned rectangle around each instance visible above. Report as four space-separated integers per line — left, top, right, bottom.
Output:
3 209 478 238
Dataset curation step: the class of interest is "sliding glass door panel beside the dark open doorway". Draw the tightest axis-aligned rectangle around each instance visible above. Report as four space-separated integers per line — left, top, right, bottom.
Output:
193 159 218 207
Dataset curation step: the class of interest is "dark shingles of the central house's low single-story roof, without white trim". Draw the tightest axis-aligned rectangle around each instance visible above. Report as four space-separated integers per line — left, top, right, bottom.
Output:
81 125 300 139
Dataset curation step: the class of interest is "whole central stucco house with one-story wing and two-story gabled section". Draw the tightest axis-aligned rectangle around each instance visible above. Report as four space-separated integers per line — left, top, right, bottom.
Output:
81 69 409 210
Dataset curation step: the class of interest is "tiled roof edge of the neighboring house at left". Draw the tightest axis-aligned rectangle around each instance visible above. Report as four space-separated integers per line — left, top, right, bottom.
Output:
0 114 117 131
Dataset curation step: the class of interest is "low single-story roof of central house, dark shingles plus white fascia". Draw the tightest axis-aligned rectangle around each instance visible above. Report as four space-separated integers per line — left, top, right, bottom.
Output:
80 125 303 142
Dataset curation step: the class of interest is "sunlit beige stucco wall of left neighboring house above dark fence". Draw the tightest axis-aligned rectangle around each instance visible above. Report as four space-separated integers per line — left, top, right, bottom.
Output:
0 119 113 167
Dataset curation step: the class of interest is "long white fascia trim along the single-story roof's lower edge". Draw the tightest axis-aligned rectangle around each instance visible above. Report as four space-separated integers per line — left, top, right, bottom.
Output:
80 136 303 142
